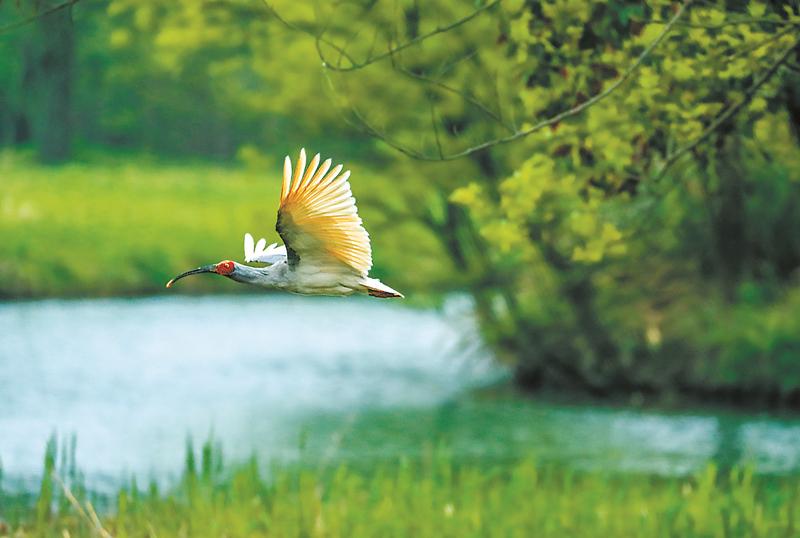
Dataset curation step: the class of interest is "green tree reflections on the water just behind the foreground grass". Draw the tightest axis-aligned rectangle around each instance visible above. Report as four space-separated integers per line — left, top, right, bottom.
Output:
298 396 800 475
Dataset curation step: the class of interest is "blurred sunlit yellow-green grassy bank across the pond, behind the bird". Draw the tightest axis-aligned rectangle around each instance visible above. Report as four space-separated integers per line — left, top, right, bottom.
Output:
0 152 450 298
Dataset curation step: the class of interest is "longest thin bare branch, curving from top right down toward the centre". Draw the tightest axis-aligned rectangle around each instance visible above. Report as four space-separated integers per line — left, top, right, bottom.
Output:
344 0 694 161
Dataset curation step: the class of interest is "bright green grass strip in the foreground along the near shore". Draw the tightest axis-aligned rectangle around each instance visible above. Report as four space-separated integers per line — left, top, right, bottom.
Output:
0 438 800 538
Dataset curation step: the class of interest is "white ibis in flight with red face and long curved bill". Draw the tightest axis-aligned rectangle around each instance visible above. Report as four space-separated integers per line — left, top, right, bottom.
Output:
167 149 403 298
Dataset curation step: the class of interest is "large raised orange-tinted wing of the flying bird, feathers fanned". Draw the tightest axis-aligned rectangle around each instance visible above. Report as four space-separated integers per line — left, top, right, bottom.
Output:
275 149 372 276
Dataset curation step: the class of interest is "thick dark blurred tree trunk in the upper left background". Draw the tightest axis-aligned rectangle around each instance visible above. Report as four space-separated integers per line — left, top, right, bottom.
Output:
30 1 75 163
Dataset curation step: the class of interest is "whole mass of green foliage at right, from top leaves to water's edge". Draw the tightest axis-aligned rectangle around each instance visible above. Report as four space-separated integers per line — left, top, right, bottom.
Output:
444 2 800 401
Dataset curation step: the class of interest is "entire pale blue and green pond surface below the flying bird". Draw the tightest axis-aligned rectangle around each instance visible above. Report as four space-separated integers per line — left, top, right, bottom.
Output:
0 295 800 489
